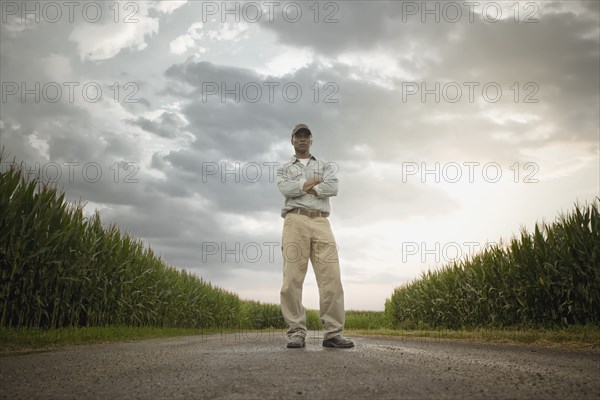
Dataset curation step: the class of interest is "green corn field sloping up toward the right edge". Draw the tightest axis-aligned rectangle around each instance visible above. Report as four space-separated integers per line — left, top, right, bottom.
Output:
386 198 600 328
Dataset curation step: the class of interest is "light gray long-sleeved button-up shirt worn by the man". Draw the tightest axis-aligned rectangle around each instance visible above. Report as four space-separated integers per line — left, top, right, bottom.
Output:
277 155 338 217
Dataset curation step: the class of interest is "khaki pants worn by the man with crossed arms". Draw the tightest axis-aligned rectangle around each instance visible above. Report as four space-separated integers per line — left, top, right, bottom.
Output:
281 213 344 339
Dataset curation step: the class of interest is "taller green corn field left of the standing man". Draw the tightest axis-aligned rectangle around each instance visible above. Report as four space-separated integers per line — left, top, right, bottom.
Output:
0 154 283 329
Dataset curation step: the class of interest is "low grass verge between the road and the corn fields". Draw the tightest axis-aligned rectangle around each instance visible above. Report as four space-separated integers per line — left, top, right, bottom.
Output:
0 326 600 356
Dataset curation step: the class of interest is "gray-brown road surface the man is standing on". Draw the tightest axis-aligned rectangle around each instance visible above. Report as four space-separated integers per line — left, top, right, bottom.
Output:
0 333 600 400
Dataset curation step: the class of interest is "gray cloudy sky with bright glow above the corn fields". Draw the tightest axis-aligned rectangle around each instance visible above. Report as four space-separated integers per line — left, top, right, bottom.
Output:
0 1 600 310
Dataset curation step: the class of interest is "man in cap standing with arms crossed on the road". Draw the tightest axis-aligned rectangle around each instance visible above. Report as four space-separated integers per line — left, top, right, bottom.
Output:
277 124 354 348
